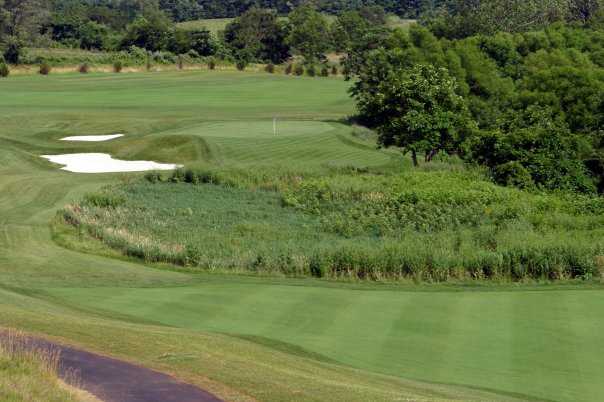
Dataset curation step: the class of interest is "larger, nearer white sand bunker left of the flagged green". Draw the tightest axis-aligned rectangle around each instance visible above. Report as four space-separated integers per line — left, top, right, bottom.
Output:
42 153 182 173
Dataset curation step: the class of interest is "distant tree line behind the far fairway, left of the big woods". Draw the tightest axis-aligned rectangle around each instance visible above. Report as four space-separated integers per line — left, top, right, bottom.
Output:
0 0 398 65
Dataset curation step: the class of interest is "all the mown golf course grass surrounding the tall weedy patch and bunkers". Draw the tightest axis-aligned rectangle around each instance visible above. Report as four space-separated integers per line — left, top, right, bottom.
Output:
0 72 604 401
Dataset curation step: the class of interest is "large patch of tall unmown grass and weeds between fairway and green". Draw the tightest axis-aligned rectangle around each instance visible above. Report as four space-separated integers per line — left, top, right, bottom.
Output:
63 169 604 281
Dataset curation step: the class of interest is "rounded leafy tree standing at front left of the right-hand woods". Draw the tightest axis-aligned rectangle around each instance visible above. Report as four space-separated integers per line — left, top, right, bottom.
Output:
353 64 474 166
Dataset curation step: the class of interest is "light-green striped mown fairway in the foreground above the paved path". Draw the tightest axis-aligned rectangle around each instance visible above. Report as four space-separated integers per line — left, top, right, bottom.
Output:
50 283 604 401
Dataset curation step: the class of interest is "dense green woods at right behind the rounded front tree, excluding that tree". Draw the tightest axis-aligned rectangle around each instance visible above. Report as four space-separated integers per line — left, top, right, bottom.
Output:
352 24 604 192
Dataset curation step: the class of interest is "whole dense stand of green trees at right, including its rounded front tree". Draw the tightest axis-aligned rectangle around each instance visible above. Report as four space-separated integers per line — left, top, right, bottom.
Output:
346 0 604 193
